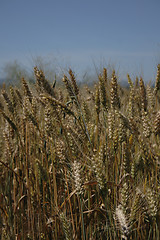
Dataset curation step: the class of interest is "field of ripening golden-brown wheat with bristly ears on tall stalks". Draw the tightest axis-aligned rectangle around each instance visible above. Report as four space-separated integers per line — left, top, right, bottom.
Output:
0 65 160 240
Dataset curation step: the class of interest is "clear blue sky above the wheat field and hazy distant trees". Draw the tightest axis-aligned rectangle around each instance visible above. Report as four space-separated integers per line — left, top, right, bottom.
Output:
0 0 160 81
